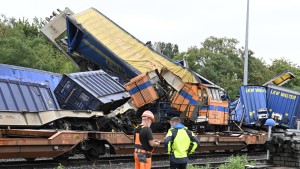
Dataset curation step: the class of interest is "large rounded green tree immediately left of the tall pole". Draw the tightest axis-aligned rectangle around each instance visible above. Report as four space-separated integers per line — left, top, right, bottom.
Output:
196 37 243 97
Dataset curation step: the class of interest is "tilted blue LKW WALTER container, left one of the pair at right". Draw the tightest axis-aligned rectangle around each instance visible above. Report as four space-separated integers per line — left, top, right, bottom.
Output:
230 86 267 125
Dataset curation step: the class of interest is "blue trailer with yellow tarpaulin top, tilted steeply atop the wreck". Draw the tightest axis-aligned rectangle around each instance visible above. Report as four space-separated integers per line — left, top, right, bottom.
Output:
67 8 199 83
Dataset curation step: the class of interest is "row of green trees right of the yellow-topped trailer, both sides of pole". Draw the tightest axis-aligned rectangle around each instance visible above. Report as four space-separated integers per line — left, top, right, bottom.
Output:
173 36 300 98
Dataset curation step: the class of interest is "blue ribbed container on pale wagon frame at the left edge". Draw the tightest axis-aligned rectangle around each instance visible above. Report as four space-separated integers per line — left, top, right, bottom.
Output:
0 66 104 129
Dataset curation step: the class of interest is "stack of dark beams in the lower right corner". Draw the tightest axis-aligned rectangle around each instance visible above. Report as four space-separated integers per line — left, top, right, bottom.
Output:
268 129 300 168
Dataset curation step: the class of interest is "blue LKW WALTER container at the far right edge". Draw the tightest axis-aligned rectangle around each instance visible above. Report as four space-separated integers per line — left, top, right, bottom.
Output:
267 85 300 129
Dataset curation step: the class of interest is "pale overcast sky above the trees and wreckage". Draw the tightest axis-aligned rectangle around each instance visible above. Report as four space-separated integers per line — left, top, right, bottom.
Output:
0 0 300 65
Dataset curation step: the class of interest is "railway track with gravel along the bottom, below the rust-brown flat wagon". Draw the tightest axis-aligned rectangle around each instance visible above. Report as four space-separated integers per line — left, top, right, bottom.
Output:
0 152 266 169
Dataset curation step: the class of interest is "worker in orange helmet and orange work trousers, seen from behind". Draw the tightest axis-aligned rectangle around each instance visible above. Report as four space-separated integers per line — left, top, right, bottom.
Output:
134 110 160 169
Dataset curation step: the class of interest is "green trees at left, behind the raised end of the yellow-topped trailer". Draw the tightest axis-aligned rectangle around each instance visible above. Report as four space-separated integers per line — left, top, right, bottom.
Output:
0 15 76 73
